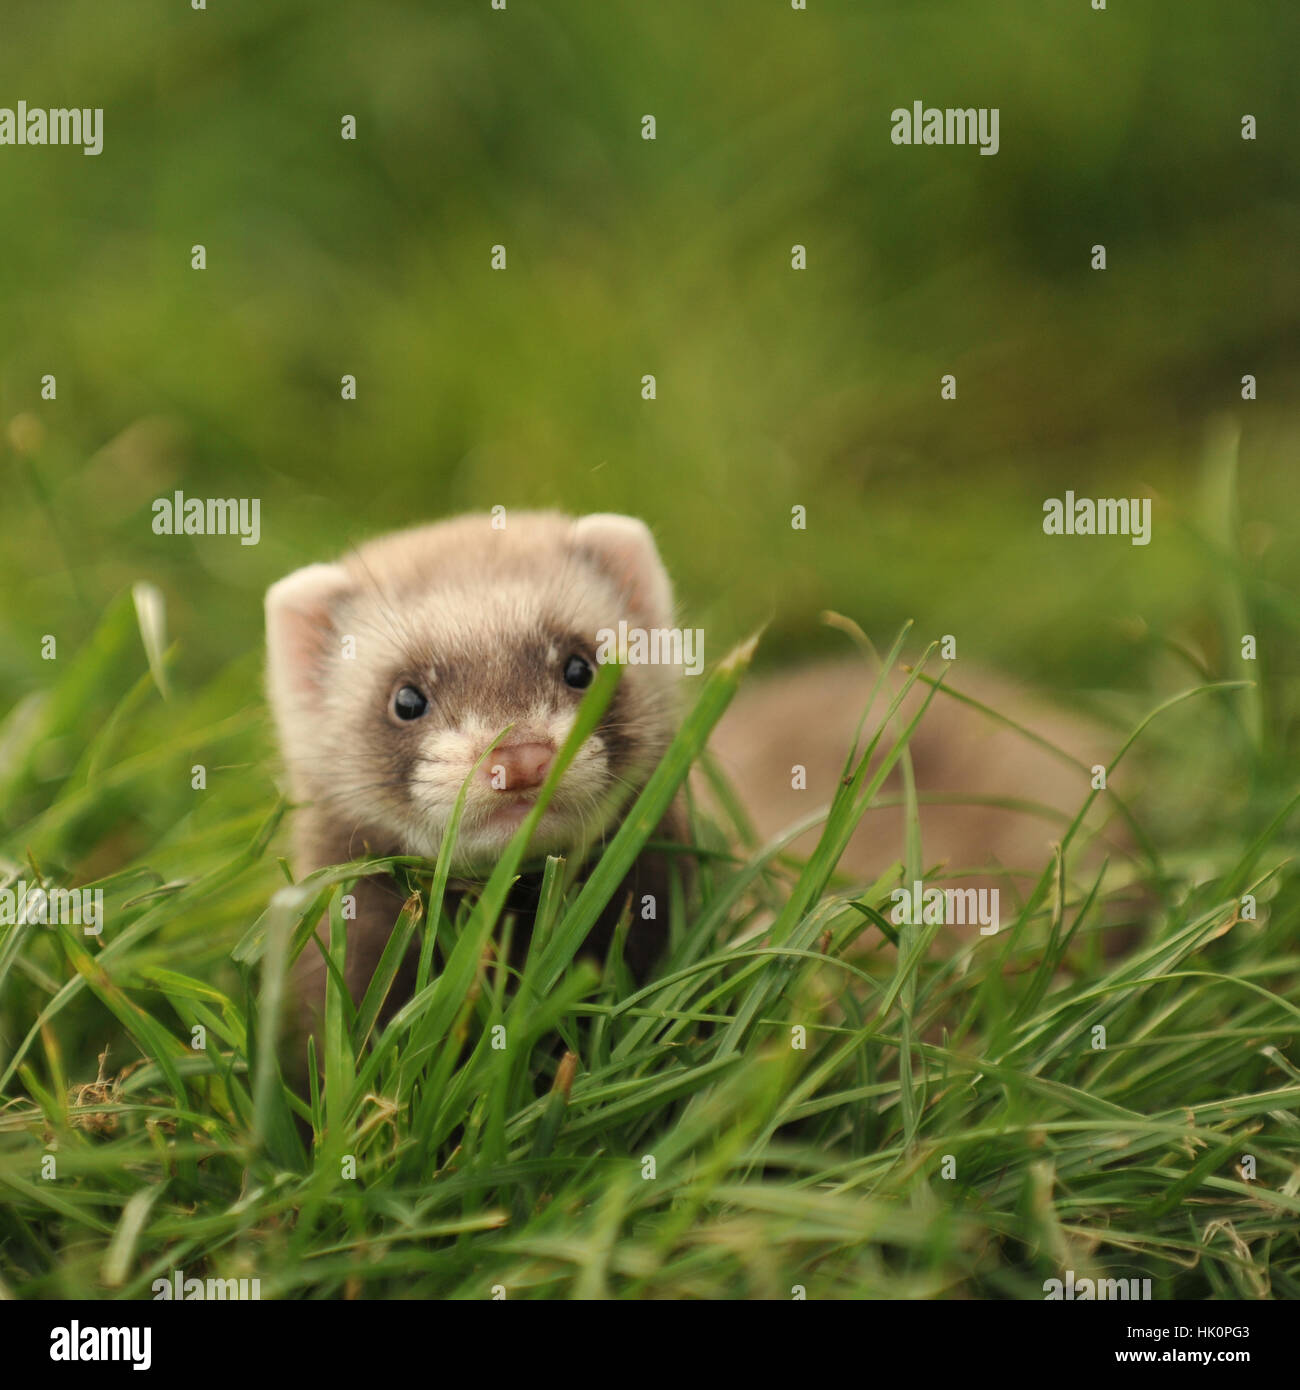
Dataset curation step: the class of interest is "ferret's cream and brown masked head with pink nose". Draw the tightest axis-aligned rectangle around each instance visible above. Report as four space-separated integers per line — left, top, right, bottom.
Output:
266 513 679 872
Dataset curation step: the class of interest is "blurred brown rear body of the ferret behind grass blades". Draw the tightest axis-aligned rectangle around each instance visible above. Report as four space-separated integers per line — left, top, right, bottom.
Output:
710 659 1132 924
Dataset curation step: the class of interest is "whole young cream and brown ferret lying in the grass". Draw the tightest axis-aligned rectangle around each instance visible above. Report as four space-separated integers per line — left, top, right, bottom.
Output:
266 512 1128 1050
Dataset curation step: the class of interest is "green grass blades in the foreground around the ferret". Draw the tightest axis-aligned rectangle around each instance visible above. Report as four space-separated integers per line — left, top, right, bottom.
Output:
0 569 1300 1298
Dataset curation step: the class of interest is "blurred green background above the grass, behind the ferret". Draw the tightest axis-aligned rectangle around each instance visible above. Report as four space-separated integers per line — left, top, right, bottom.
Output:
0 0 1300 745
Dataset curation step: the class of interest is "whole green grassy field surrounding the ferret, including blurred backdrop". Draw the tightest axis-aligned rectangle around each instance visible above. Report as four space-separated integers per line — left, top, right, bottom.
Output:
0 0 1300 1298
